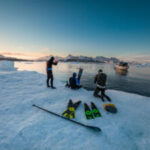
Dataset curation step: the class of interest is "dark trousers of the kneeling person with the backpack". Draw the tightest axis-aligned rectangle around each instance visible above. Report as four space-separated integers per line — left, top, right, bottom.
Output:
94 87 111 101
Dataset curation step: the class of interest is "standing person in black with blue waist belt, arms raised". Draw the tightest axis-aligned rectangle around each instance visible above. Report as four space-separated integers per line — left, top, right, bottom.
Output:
46 57 58 89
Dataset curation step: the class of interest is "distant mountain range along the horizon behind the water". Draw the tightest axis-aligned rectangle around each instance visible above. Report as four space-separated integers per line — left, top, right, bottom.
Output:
37 55 120 63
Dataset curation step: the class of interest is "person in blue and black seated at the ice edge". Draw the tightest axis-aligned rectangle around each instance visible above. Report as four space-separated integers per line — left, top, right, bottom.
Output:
66 72 81 89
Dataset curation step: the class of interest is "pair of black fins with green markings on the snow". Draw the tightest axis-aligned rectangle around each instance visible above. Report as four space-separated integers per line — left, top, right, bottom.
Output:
84 102 102 120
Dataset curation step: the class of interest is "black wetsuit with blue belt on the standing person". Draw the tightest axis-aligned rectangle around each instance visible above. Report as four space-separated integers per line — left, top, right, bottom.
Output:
47 60 57 87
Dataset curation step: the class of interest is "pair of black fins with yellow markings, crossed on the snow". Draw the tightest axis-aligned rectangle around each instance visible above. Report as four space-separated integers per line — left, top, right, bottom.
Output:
62 100 81 119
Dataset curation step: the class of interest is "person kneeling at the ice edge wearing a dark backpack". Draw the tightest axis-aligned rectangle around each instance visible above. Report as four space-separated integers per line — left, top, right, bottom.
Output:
94 69 111 101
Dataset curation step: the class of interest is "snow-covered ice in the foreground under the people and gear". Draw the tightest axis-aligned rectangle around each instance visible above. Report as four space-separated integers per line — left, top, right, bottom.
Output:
0 61 150 150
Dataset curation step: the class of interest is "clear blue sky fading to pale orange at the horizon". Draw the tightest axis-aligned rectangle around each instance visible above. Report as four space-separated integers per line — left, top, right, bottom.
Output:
0 0 150 59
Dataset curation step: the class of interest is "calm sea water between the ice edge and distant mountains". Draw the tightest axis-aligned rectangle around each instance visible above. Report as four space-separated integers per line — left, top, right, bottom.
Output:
15 62 150 97
